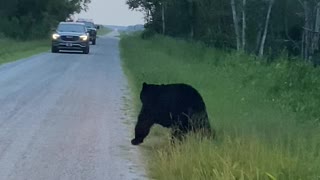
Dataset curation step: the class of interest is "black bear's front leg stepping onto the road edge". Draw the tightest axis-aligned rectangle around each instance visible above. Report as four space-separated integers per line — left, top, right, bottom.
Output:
131 113 153 145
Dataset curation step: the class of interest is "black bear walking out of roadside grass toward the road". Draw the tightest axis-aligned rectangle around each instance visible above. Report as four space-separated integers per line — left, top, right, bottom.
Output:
131 83 214 145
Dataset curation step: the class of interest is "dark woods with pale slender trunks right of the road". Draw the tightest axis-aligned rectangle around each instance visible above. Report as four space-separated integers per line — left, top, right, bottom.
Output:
126 0 320 61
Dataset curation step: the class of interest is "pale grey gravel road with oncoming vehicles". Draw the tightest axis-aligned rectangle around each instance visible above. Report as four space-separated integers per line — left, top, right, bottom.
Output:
0 32 145 180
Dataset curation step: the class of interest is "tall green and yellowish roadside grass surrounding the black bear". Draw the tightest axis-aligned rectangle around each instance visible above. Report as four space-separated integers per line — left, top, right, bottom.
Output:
121 36 320 180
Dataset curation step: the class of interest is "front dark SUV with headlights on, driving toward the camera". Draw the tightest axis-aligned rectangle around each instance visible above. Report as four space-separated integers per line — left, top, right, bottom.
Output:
51 22 90 54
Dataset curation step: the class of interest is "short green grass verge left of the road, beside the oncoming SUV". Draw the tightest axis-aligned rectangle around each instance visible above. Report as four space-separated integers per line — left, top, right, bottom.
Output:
0 39 50 64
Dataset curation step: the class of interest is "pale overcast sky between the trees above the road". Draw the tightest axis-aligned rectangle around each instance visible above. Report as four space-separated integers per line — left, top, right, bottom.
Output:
75 0 144 26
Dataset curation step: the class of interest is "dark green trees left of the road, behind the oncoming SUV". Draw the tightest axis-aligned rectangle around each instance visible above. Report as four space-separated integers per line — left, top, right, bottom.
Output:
0 0 91 39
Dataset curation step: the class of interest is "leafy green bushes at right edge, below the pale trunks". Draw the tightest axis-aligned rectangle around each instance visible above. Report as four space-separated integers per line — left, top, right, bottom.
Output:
238 58 320 124
